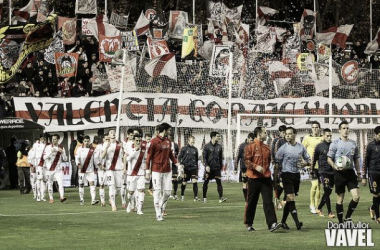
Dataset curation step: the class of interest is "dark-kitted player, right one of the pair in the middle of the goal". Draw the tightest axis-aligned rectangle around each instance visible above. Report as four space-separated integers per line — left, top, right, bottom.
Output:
203 131 227 203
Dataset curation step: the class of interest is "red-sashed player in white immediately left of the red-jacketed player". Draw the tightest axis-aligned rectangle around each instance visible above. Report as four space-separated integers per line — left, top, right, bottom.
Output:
126 134 147 215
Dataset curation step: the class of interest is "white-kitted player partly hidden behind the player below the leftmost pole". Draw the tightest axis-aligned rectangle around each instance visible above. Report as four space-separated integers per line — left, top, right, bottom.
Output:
94 134 110 207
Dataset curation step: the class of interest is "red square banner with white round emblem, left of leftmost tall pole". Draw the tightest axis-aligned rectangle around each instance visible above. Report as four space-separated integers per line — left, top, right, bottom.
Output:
99 34 121 62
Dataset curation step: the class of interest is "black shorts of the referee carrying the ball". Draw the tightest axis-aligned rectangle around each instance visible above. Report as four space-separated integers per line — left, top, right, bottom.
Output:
334 169 359 194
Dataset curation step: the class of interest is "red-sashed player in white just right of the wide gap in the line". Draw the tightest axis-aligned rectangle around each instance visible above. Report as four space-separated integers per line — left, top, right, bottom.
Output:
75 135 99 205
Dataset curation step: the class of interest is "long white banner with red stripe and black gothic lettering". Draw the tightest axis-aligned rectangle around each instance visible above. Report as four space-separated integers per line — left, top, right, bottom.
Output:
14 92 380 132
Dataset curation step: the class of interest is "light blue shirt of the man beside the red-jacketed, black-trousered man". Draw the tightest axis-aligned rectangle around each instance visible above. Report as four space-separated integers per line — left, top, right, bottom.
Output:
276 142 310 173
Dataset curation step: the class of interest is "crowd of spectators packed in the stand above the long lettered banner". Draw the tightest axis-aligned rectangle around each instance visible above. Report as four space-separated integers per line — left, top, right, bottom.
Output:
0 15 380 117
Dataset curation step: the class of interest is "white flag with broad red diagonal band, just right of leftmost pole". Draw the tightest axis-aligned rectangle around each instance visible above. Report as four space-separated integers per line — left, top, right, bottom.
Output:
145 53 177 81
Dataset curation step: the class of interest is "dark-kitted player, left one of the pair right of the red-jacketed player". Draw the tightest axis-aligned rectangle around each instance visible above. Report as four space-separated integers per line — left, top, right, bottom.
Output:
178 135 200 201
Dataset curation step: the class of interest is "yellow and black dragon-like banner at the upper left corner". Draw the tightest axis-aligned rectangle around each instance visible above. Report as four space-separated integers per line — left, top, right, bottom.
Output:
0 14 57 83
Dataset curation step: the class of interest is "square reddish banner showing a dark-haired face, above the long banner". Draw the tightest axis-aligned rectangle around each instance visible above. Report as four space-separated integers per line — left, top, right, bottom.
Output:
55 53 79 77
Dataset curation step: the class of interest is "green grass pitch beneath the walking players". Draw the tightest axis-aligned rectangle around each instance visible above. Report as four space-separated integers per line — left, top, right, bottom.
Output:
0 181 380 250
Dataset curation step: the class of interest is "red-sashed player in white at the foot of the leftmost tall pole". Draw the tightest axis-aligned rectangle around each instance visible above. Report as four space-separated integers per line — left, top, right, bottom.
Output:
102 129 126 211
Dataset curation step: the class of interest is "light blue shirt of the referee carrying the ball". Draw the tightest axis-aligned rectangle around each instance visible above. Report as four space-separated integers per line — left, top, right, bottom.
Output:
327 138 359 169
